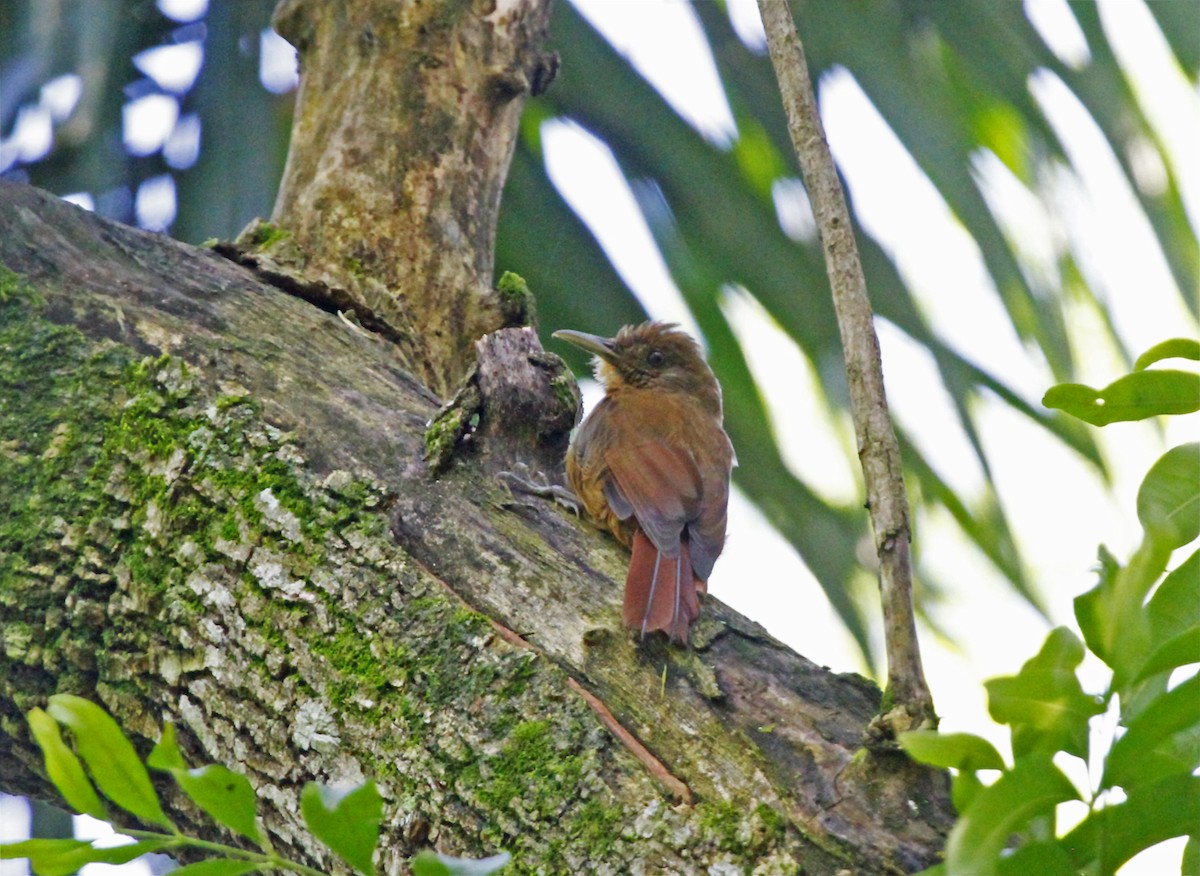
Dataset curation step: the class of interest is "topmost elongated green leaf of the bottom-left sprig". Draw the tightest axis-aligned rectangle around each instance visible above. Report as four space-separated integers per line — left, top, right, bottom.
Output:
47 694 175 832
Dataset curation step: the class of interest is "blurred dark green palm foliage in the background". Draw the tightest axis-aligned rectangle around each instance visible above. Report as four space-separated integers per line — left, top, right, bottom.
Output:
0 0 1200 661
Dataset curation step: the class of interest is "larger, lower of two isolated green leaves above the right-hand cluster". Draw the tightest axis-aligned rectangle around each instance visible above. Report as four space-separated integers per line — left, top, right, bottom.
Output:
1042 368 1200 426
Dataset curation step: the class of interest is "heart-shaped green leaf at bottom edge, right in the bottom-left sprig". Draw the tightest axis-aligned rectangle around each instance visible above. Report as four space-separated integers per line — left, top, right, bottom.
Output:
300 781 383 876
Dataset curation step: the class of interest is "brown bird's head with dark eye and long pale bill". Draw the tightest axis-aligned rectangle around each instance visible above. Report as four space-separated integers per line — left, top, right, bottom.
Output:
553 322 721 418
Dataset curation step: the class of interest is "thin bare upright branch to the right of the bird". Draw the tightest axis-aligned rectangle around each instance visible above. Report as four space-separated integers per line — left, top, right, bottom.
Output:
758 0 937 739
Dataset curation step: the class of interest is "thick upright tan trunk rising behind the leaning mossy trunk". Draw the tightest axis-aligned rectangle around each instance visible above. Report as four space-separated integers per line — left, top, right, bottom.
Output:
271 0 557 396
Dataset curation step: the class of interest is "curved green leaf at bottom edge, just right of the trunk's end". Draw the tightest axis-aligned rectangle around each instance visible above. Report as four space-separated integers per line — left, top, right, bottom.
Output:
946 754 1078 876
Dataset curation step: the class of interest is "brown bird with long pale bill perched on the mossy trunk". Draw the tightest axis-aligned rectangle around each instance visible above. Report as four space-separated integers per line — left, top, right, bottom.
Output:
554 323 733 642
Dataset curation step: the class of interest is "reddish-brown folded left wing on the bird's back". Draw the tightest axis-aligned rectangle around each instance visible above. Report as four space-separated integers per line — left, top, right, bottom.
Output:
605 439 701 557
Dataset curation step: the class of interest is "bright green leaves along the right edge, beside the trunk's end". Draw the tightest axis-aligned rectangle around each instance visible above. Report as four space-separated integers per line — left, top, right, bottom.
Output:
901 340 1200 876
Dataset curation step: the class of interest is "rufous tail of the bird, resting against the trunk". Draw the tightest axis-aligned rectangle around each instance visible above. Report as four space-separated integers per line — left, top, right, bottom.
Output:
624 529 707 642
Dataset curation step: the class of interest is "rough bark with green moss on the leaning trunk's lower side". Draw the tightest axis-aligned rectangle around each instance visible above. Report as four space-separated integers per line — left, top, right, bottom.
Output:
0 266 835 874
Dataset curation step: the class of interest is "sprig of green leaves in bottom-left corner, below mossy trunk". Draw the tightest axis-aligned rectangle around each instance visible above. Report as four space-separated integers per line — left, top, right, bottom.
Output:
0 694 509 876
